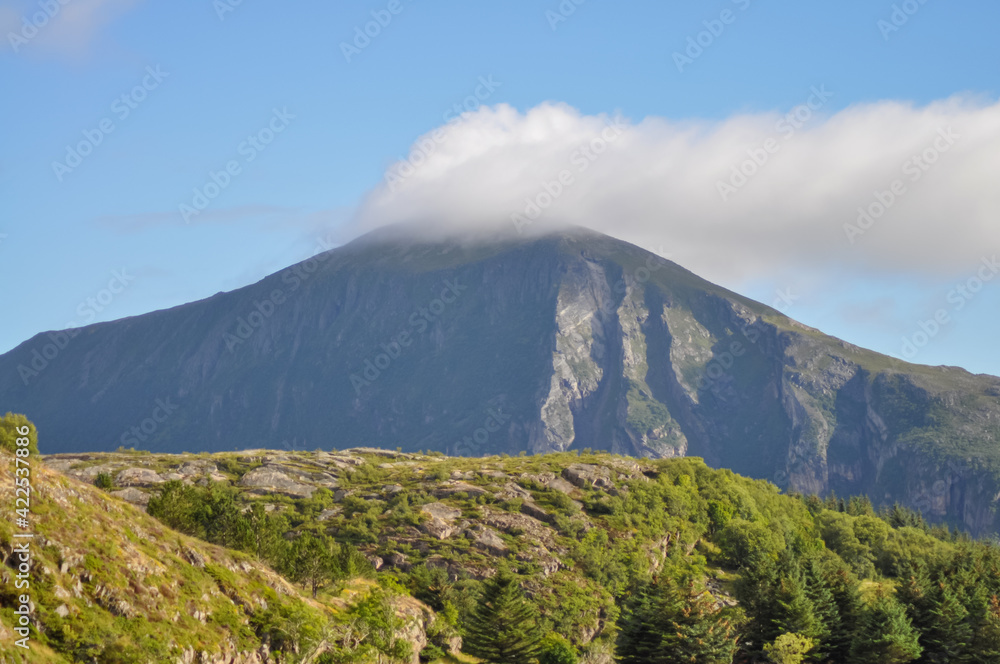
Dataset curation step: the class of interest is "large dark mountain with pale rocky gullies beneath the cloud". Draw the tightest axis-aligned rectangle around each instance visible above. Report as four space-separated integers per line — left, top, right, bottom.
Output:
0 228 1000 533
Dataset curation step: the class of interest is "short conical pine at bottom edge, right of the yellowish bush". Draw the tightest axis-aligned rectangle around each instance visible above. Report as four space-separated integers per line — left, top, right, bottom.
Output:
851 591 923 664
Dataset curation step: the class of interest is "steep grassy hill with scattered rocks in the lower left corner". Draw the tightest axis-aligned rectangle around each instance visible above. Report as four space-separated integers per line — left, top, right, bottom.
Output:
0 440 433 664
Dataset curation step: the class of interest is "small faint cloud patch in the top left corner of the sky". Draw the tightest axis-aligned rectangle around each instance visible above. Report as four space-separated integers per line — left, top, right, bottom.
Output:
0 0 141 57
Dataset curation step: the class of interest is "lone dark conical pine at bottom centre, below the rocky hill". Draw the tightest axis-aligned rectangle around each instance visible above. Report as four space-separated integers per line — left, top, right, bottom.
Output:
463 570 542 664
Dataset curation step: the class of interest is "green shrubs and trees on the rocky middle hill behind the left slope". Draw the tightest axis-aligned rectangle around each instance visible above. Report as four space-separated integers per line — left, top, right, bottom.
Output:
121 450 1000 664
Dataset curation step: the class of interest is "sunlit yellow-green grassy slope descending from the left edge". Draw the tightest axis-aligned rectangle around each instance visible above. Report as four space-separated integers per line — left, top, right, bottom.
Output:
0 451 424 662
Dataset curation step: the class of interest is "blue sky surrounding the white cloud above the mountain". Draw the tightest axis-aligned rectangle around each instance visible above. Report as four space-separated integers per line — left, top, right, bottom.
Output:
0 0 1000 374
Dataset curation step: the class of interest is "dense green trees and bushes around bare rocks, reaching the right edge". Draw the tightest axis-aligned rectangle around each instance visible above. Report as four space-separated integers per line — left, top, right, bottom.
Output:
137 448 1000 664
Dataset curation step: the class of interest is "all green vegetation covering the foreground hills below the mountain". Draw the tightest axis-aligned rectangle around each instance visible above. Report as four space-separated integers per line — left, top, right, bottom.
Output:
9 408 1000 664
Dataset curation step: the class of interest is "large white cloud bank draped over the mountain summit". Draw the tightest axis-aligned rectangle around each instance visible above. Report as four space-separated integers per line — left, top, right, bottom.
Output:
357 97 1000 284
